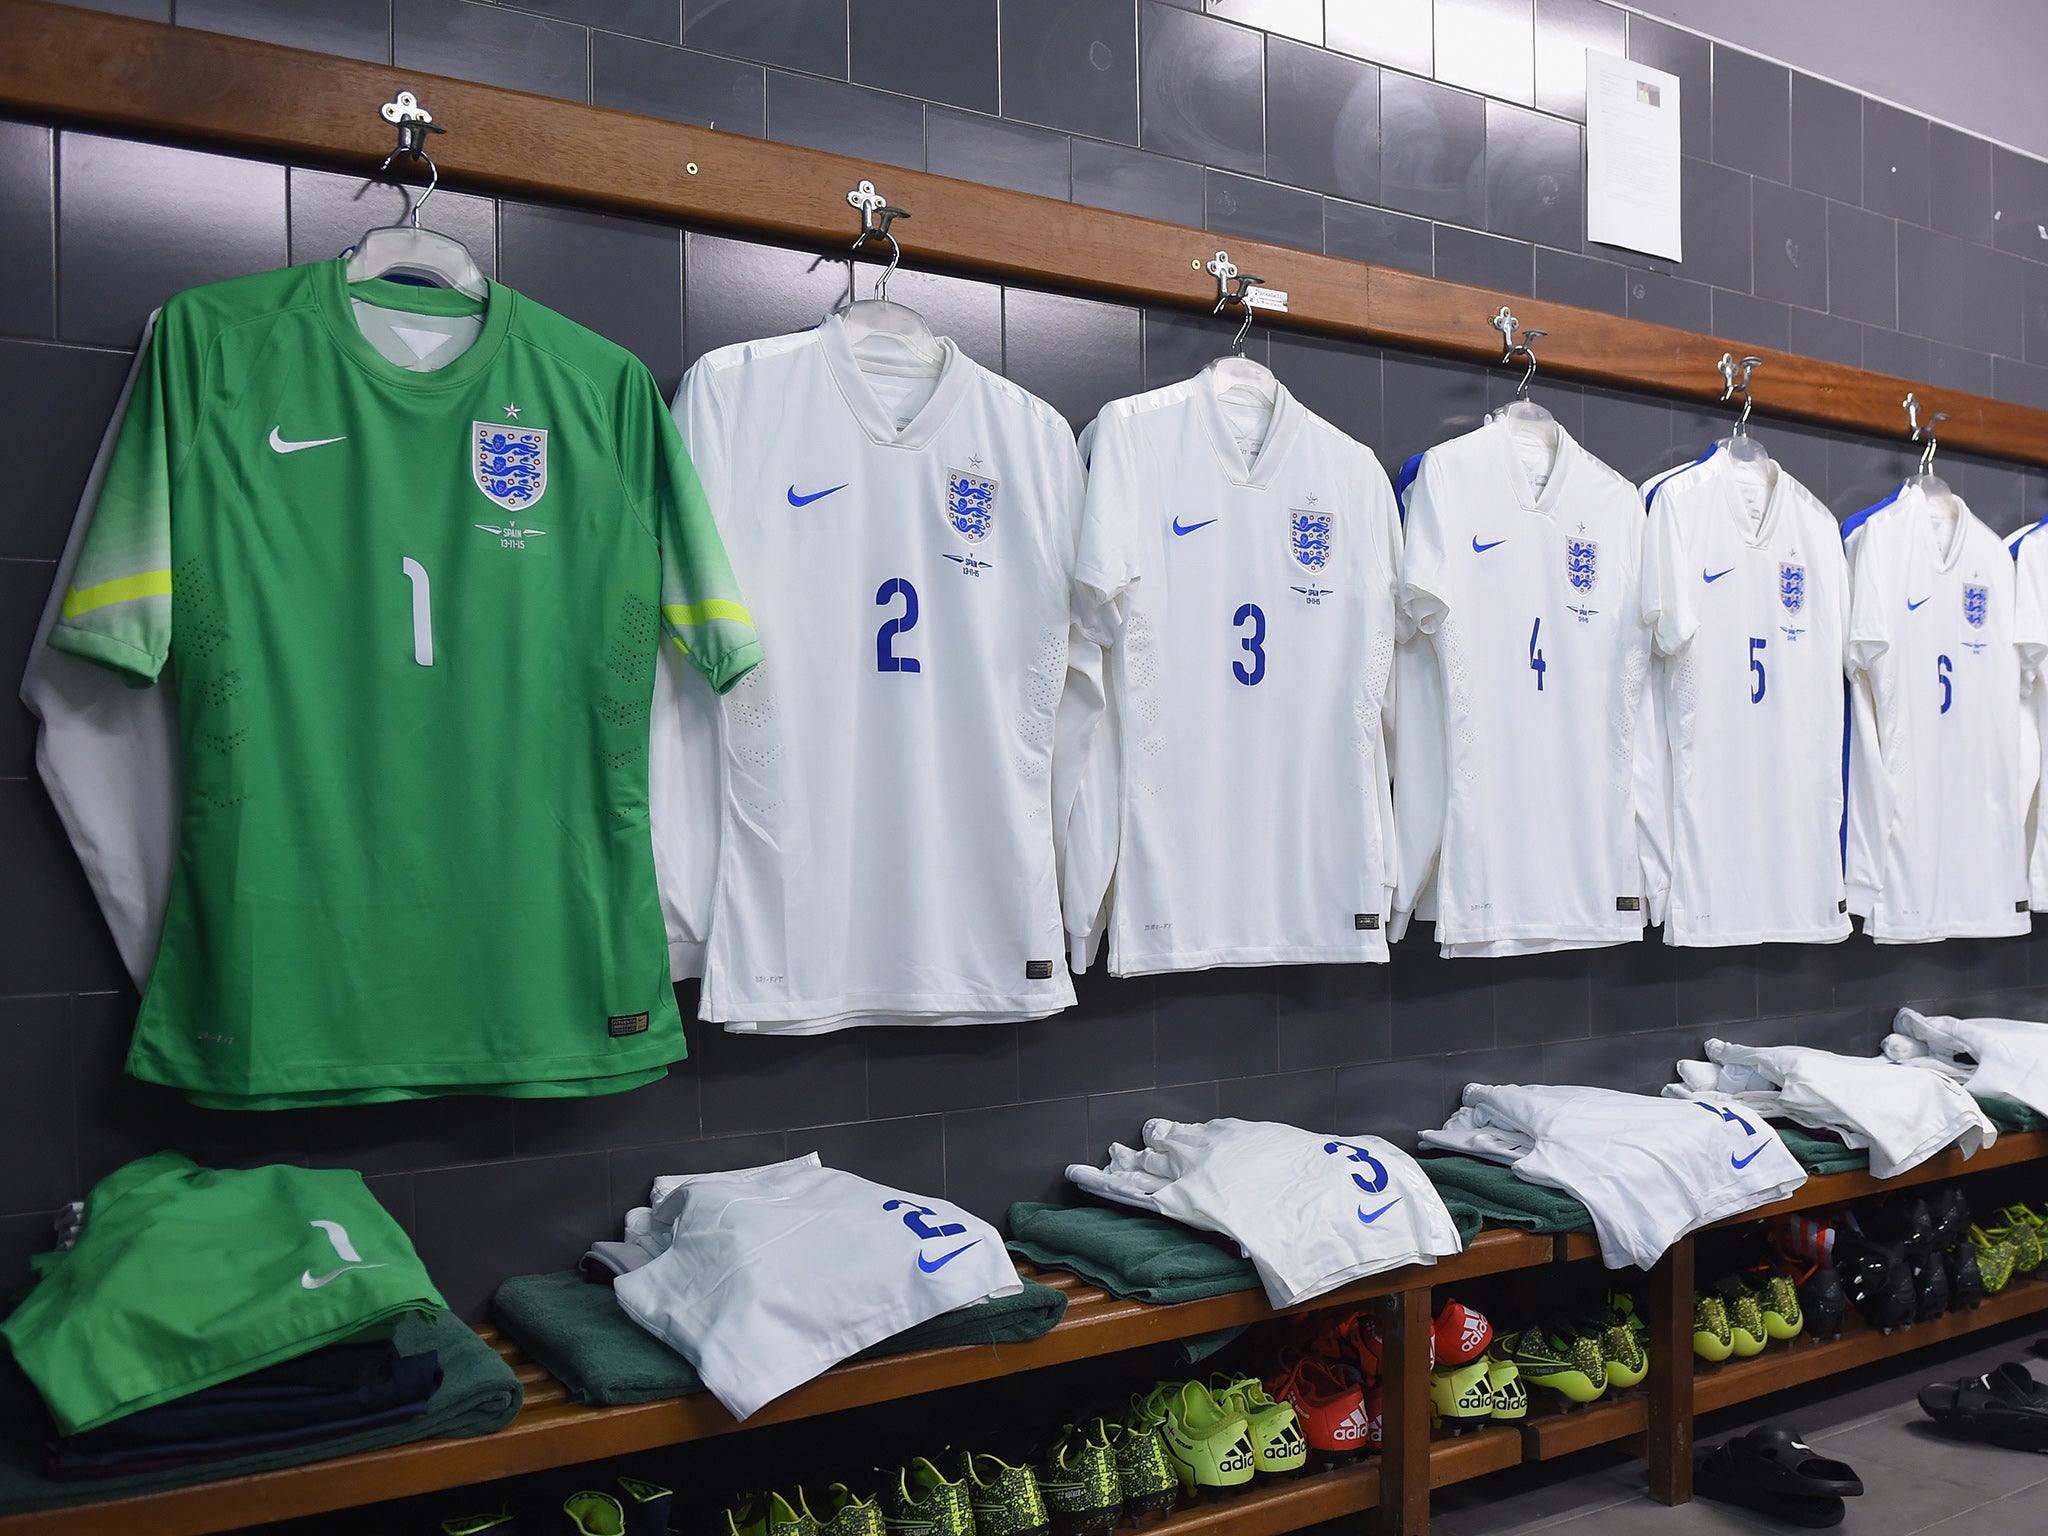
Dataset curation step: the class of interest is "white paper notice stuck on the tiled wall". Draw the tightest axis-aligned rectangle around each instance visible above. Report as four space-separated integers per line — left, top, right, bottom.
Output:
1585 49 1681 262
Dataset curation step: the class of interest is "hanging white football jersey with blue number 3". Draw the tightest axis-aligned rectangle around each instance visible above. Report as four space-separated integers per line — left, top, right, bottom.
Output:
1065 371 1401 975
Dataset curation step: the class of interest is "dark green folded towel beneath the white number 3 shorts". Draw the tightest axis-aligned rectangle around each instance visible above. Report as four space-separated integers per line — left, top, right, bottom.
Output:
1010 1202 1260 1307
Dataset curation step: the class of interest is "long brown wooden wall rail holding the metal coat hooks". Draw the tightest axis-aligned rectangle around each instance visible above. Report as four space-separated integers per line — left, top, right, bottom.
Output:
12 0 2048 465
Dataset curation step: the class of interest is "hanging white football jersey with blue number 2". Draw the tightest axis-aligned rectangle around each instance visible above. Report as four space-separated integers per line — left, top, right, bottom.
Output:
657 315 1083 1034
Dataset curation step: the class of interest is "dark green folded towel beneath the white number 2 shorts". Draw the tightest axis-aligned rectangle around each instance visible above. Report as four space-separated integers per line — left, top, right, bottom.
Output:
492 1270 1067 1403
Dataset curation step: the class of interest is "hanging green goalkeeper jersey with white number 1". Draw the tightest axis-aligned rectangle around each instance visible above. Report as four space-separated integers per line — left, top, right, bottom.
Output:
51 260 760 1108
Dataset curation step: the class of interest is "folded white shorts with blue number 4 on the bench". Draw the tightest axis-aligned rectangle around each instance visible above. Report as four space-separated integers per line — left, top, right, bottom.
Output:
1421 1083 1806 1270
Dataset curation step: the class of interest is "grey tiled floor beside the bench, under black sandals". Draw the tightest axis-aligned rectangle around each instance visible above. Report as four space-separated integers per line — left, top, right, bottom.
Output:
1432 1321 2048 1536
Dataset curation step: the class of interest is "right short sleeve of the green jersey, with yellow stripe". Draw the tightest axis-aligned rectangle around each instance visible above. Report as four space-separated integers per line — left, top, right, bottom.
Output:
616 369 762 692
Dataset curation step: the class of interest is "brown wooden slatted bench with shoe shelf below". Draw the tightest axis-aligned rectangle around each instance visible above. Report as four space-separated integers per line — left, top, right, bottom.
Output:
0 1133 2048 1536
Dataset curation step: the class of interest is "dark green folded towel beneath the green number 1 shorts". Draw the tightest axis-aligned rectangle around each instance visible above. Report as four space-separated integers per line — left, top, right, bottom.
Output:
0 1313 520 1513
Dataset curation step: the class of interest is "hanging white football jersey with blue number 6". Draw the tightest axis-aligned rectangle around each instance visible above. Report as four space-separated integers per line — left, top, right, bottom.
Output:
1843 481 2040 944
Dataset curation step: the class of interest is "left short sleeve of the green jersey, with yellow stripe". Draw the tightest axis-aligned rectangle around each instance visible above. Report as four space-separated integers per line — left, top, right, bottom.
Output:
49 301 192 682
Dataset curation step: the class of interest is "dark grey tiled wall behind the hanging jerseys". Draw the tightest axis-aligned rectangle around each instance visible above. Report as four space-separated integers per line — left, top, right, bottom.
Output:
12 0 2048 1315
